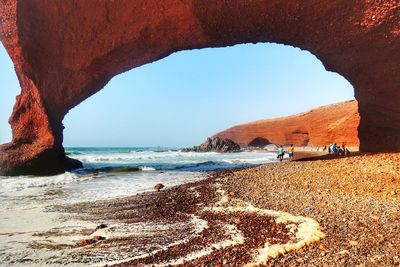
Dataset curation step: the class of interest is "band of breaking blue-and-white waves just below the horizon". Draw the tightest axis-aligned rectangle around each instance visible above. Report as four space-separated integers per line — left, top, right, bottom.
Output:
65 149 276 173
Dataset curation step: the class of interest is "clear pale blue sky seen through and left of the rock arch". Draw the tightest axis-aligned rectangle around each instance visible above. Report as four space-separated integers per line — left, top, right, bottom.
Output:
0 44 354 147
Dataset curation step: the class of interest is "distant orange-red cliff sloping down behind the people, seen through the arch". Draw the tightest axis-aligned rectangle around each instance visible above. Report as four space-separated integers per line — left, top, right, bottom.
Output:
216 101 360 149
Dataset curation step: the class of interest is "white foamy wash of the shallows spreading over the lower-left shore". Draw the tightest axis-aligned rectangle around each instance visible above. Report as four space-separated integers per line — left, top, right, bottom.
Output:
0 171 208 266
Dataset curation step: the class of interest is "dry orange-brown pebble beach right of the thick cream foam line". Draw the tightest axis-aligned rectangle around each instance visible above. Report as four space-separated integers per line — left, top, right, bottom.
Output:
223 154 400 266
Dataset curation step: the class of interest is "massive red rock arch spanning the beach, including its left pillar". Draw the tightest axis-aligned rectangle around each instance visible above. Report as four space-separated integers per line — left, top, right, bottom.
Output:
0 0 400 174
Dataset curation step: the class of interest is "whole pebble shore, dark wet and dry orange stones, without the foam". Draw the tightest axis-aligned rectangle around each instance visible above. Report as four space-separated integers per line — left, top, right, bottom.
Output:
54 154 400 266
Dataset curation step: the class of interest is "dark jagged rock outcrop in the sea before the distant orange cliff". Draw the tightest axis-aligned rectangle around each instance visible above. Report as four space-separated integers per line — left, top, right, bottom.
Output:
182 136 240 153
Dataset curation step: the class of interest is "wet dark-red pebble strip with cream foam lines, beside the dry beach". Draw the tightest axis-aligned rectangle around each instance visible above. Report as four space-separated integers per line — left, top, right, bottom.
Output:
63 172 324 266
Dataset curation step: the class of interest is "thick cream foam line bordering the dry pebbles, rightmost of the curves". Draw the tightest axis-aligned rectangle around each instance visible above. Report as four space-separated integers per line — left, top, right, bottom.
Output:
209 190 325 267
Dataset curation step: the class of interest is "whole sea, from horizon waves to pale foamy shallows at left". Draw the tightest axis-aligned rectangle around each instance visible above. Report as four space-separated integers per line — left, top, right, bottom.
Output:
0 147 276 266
